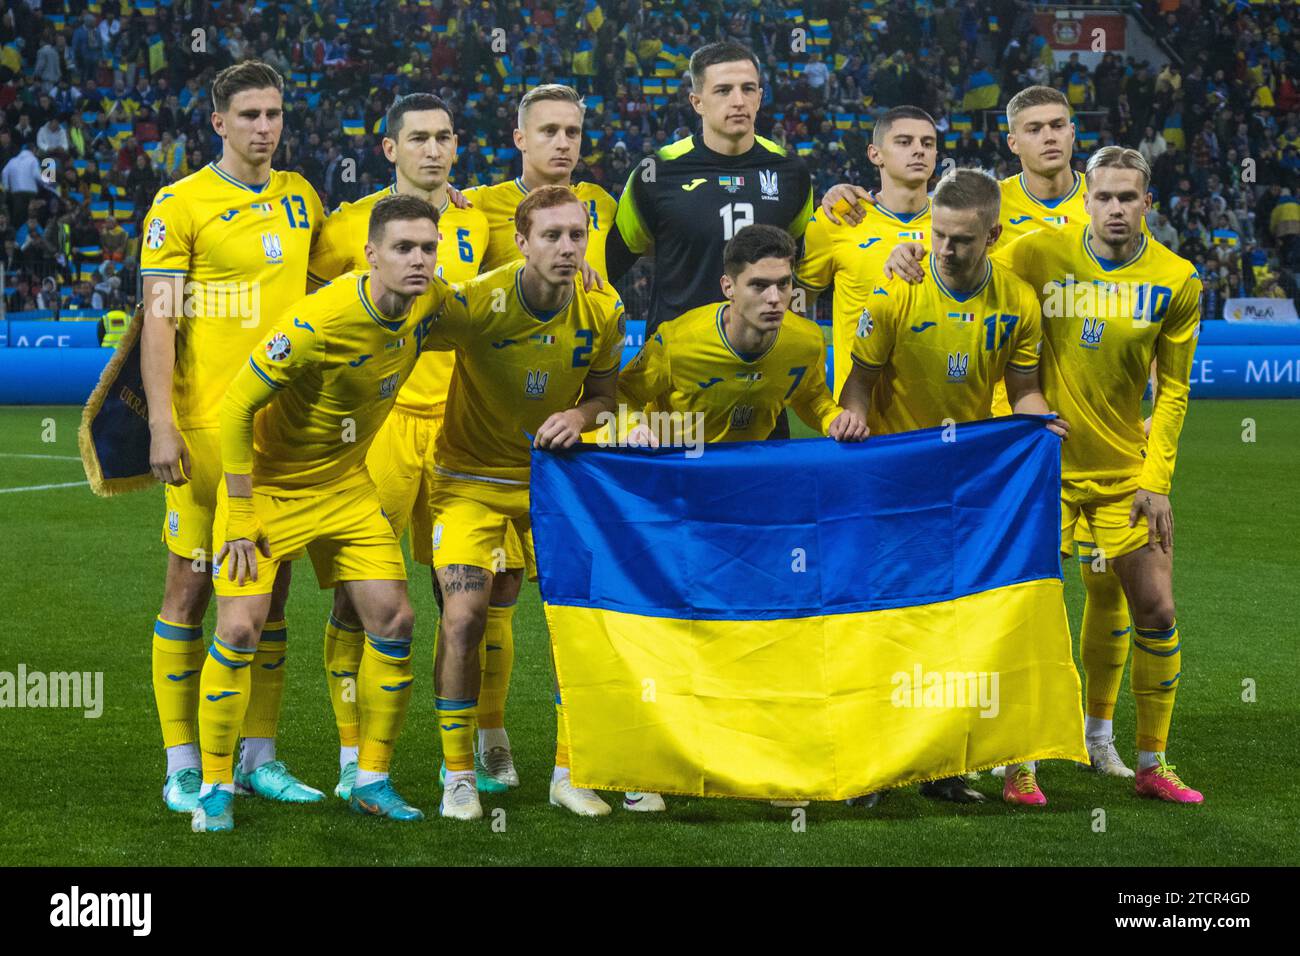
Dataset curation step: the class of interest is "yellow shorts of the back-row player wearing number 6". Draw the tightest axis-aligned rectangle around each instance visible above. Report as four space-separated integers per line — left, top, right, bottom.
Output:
365 405 525 568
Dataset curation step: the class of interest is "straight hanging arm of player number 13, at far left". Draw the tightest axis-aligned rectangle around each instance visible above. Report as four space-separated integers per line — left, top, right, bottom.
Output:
140 200 194 485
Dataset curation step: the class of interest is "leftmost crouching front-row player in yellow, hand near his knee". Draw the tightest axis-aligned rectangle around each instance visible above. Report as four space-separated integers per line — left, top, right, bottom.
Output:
194 195 450 831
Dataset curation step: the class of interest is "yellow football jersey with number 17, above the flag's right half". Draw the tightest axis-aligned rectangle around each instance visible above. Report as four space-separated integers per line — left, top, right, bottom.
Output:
853 256 1043 434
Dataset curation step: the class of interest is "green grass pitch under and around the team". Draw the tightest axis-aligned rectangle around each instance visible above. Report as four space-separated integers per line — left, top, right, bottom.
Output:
0 401 1300 866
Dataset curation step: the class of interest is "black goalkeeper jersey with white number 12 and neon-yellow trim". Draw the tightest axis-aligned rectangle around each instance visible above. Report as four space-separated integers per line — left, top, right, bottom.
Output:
606 133 813 333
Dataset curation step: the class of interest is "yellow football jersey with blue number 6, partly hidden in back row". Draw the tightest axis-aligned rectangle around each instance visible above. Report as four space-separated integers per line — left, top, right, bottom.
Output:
308 183 488 414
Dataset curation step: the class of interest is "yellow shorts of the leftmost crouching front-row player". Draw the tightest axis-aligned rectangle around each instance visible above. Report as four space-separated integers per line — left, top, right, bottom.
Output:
212 483 406 597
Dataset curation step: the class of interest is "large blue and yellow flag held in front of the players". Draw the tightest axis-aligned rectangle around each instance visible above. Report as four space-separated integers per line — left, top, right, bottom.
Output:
532 415 1087 800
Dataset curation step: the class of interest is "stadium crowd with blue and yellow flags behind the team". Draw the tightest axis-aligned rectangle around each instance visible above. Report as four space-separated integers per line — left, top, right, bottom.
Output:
0 0 1300 319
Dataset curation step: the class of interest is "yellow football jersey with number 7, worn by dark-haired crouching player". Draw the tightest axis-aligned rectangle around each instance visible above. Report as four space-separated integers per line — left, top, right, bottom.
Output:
619 302 844 441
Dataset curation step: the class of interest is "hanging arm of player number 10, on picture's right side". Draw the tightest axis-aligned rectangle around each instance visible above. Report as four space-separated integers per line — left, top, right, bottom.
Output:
1128 276 1201 551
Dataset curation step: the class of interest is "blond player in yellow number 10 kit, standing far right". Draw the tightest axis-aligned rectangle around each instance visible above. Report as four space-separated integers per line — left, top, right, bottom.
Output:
1005 146 1204 804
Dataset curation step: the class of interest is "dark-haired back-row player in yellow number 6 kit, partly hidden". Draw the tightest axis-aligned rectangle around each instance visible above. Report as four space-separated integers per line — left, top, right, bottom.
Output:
302 94 491 800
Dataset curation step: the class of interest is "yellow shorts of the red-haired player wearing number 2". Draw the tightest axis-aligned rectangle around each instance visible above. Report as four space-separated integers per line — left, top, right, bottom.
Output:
432 475 537 581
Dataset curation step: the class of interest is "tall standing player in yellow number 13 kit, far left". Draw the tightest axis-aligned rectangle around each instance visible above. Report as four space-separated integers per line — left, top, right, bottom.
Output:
140 60 325 813
